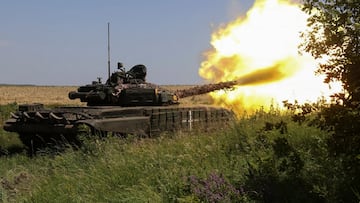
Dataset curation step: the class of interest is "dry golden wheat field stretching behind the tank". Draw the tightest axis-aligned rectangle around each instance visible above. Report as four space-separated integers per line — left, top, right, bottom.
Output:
0 85 211 106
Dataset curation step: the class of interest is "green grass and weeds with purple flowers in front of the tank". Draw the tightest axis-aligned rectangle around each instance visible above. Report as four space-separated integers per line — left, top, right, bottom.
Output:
0 102 360 202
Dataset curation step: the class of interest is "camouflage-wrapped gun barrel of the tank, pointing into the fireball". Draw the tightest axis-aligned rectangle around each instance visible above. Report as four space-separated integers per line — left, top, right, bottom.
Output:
175 80 238 98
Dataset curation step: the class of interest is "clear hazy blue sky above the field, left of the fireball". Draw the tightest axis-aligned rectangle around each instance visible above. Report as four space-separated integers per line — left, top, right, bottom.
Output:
0 0 253 85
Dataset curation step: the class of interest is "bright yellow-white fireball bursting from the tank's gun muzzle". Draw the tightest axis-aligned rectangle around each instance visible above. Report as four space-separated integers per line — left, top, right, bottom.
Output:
199 0 341 114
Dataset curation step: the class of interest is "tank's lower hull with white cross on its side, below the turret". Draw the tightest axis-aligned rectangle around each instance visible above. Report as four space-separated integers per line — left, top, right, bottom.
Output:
3 104 234 151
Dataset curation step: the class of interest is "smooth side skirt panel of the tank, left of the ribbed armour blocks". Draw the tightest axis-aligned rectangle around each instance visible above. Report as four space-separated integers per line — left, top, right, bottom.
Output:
76 116 150 134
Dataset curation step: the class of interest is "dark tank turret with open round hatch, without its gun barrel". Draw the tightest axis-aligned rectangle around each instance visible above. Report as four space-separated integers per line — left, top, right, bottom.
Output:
69 63 179 106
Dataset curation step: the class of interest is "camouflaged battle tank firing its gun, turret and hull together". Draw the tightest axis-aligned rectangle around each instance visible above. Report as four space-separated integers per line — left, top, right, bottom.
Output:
4 63 236 150
